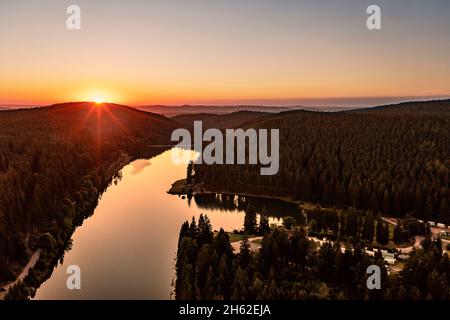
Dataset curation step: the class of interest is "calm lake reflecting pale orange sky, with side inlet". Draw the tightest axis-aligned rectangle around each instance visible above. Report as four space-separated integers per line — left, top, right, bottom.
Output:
35 150 299 299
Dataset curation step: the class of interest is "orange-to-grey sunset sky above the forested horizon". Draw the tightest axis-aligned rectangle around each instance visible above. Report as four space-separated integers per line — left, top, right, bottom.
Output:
0 0 450 105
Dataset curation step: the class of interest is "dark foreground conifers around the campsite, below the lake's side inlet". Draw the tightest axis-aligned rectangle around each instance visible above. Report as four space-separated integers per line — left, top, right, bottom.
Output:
175 215 450 300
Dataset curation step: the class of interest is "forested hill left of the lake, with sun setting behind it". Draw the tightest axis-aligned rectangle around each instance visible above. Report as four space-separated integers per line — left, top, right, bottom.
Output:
0 103 177 285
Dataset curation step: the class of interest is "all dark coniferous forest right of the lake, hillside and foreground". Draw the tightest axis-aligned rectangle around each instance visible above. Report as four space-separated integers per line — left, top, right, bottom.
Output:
175 101 450 300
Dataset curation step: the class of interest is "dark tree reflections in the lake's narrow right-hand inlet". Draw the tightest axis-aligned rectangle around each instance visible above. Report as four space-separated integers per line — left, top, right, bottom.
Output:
194 194 303 222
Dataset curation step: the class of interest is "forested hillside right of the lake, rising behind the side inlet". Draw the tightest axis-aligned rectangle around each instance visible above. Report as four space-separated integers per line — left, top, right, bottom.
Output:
195 100 450 223
